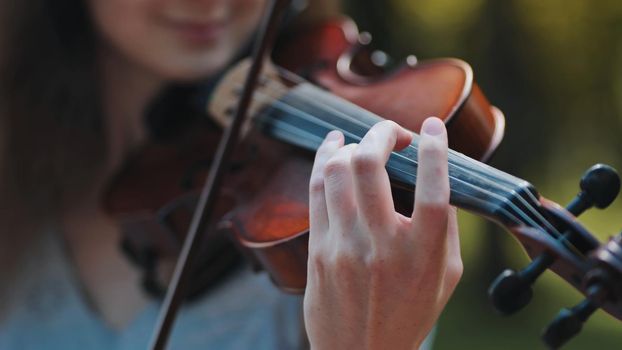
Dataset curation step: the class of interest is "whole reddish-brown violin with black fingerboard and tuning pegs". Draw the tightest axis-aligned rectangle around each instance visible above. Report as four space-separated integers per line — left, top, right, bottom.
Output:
105 3 622 347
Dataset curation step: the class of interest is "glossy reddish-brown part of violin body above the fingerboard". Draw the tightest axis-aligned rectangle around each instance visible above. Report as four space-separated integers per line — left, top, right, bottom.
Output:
274 18 505 161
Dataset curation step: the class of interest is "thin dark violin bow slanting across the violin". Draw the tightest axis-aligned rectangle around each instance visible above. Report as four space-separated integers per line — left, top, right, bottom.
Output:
149 0 291 350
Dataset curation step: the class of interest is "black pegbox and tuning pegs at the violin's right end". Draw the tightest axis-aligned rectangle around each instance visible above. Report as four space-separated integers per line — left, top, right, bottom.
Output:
489 164 622 348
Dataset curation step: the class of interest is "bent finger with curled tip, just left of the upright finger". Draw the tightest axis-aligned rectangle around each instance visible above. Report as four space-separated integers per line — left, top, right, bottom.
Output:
352 120 413 232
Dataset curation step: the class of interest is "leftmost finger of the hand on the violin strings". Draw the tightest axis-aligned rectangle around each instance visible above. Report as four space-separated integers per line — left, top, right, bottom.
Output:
309 130 343 232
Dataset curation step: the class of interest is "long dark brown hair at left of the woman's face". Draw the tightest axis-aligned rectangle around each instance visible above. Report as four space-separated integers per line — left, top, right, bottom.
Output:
0 0 105 216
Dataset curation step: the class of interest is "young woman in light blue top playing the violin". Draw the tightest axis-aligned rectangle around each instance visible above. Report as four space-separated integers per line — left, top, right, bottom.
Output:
0 0 462 349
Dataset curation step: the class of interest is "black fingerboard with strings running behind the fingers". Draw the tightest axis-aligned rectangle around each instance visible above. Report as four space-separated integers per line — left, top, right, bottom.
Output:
256 83 539 226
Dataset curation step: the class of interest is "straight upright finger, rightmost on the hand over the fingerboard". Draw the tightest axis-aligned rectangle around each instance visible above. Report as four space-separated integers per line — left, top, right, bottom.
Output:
412 118 449 254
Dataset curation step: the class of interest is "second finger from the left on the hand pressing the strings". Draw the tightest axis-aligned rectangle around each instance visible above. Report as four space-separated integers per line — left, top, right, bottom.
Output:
324 144 357 233
